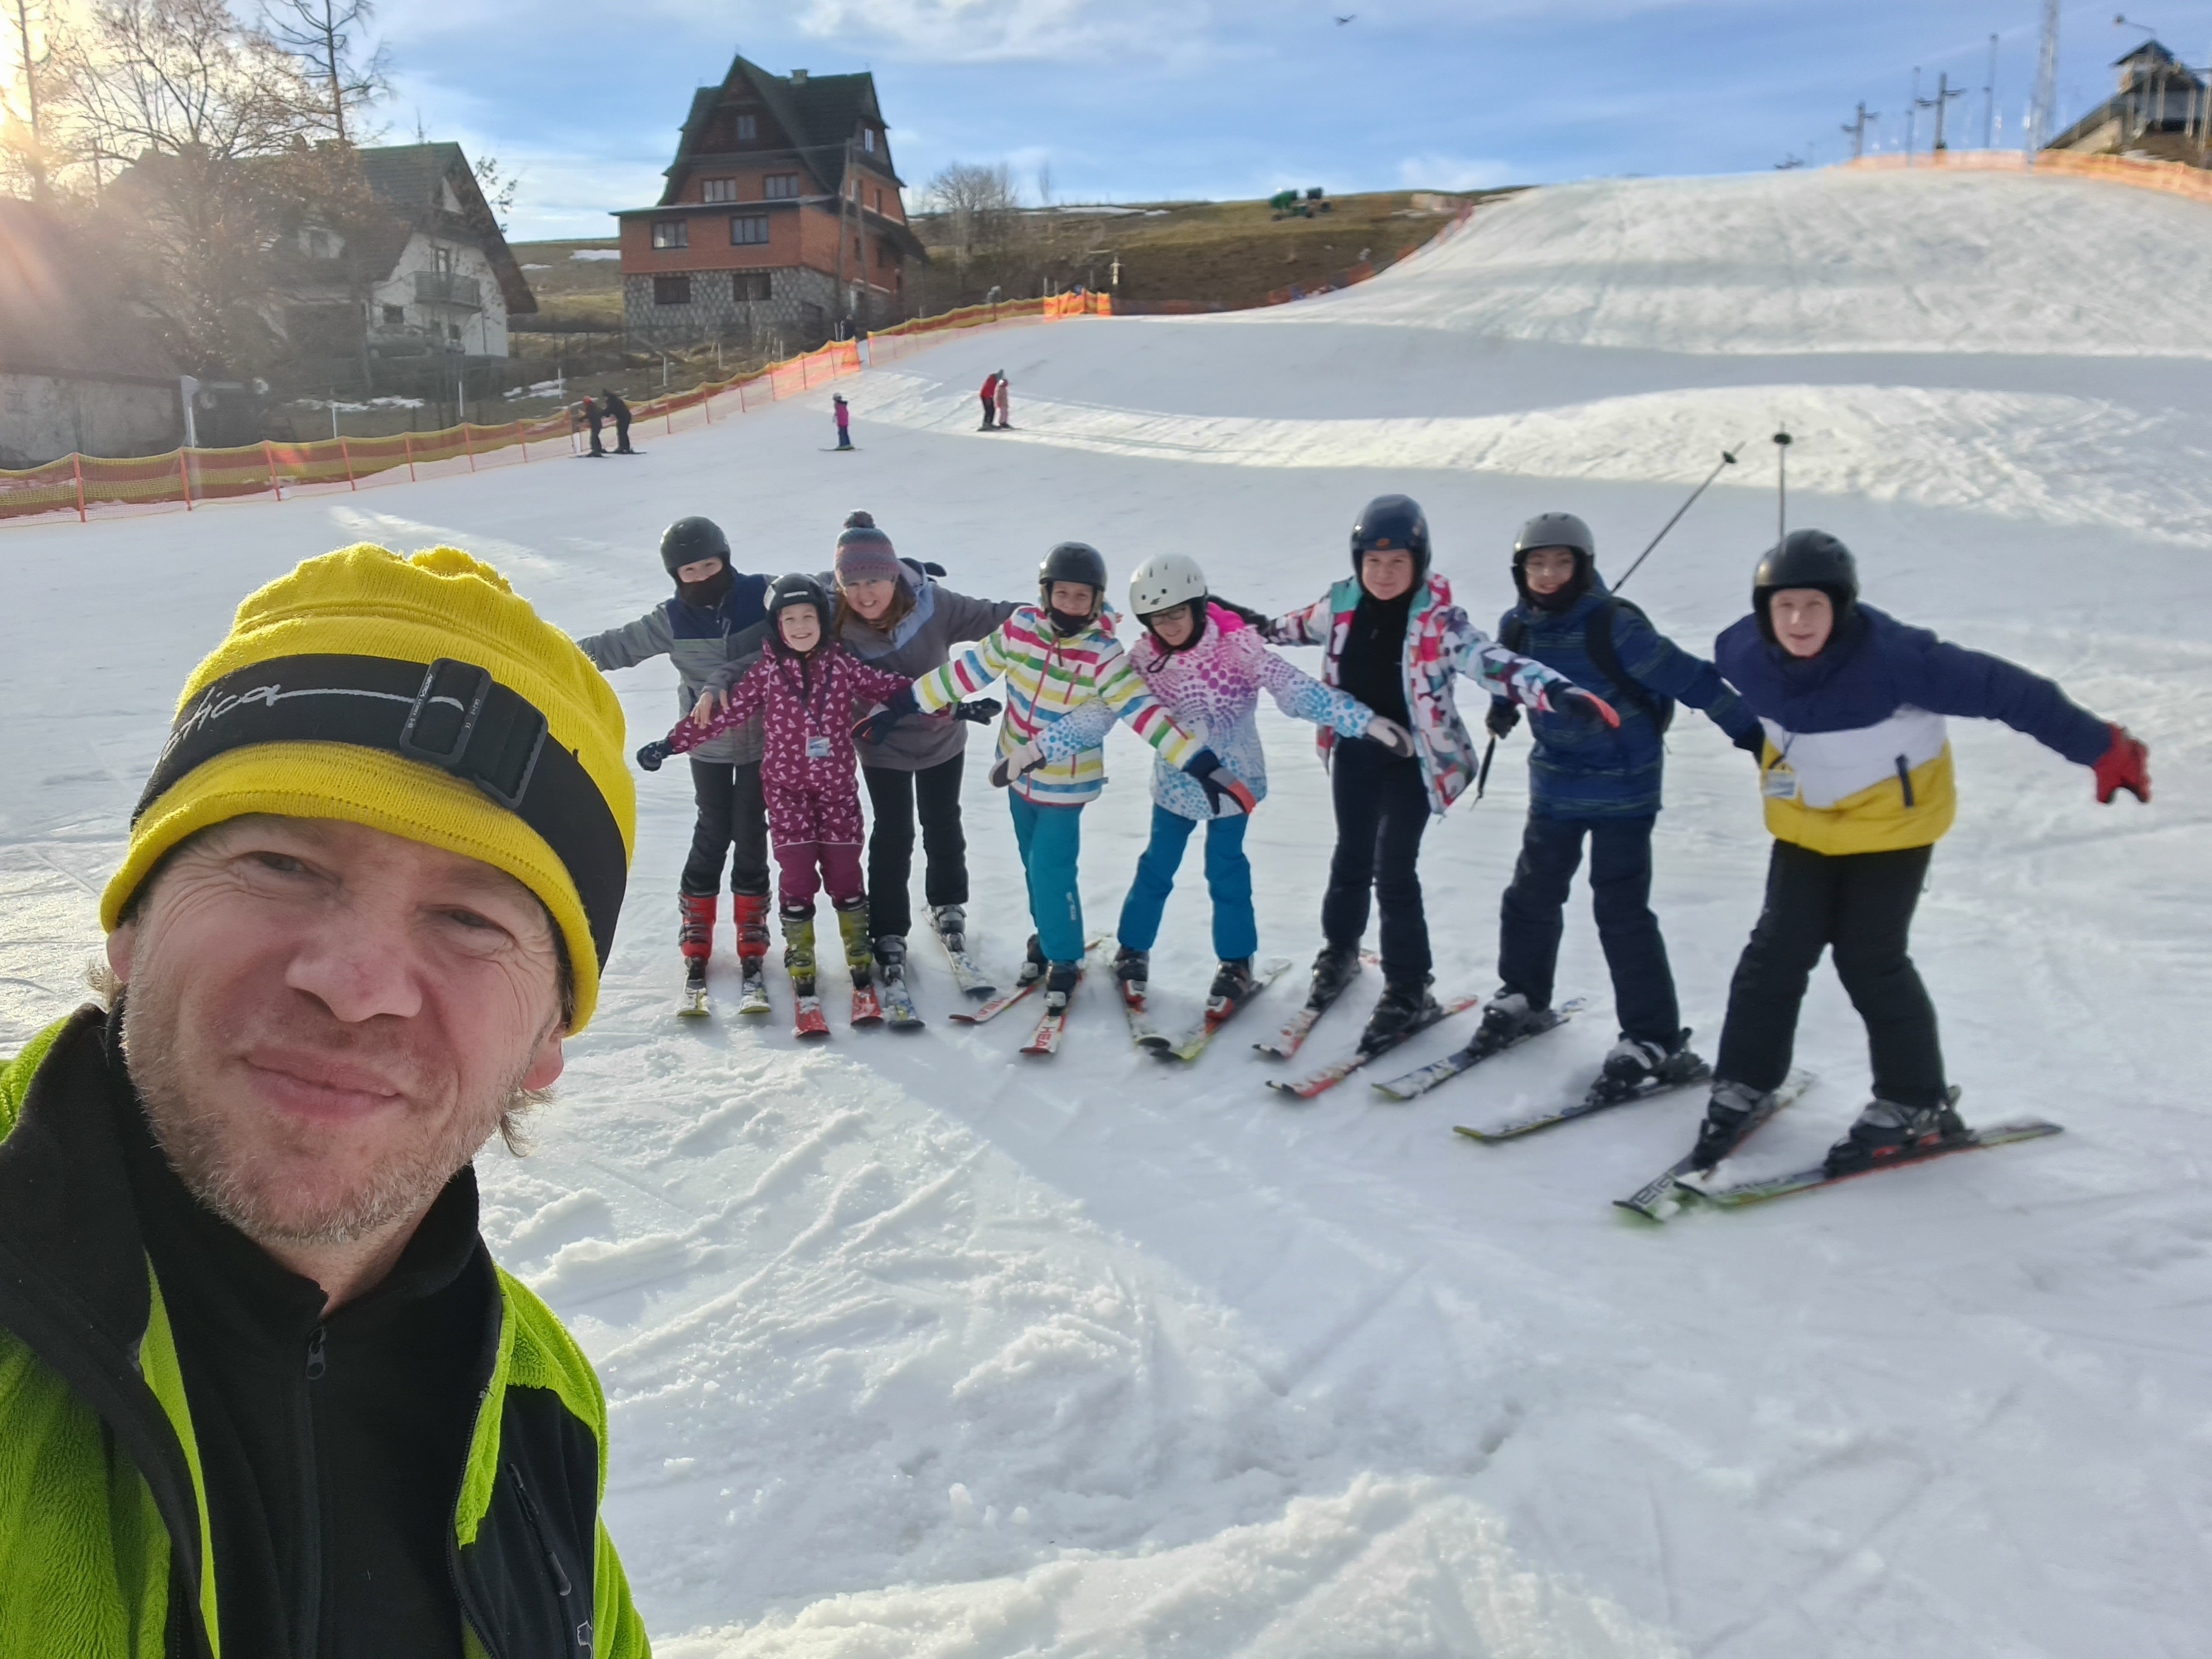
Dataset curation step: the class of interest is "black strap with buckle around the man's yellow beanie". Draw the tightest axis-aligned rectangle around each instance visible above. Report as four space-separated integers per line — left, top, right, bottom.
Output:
130 655 628 967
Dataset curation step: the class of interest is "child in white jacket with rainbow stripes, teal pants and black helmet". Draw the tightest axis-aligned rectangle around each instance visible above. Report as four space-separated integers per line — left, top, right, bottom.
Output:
867 542 1252 1013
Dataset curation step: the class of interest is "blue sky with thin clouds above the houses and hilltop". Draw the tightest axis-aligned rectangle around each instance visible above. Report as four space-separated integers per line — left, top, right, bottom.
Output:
367 0 2212 236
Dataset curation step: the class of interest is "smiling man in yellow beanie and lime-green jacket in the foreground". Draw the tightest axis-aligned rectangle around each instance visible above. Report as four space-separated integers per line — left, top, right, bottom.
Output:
0 546 646 1659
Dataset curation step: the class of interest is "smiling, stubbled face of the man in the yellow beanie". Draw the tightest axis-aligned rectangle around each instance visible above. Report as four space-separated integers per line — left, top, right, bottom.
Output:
109 814 562 1245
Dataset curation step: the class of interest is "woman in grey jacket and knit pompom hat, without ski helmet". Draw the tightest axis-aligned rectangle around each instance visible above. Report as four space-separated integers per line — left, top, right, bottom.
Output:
834 513 1020 982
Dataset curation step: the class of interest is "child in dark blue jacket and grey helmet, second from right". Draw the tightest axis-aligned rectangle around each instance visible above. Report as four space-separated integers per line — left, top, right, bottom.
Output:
1482 513 1763 1095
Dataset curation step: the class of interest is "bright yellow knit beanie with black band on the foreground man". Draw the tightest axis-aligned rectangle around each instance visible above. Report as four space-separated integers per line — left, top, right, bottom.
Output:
99 544 637 1031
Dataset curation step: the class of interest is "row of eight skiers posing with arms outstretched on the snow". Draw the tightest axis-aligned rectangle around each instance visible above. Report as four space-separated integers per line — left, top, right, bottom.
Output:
580 493 2150 1168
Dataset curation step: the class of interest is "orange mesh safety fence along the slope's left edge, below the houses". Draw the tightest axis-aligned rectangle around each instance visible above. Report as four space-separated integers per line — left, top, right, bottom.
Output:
0 294 1113 520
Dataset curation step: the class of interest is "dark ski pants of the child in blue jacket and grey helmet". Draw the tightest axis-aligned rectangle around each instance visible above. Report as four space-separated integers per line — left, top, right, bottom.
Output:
1498 814 1681 1048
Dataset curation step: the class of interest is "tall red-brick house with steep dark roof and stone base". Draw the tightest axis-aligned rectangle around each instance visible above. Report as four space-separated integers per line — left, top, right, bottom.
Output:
615 58 929 345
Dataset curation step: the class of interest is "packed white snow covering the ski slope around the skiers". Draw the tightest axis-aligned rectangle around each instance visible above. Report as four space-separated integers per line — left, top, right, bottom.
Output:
0 173 2212 1659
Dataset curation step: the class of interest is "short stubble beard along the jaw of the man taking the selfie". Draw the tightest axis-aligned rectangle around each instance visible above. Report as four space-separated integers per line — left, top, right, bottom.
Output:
119 973 553 1247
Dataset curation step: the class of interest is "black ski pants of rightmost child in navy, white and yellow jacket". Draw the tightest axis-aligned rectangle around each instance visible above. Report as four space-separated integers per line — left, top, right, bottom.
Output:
1714 840 1945 1106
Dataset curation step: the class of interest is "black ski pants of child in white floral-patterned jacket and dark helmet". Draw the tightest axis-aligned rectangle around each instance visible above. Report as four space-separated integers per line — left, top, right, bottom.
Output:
1321 737 1429 984
